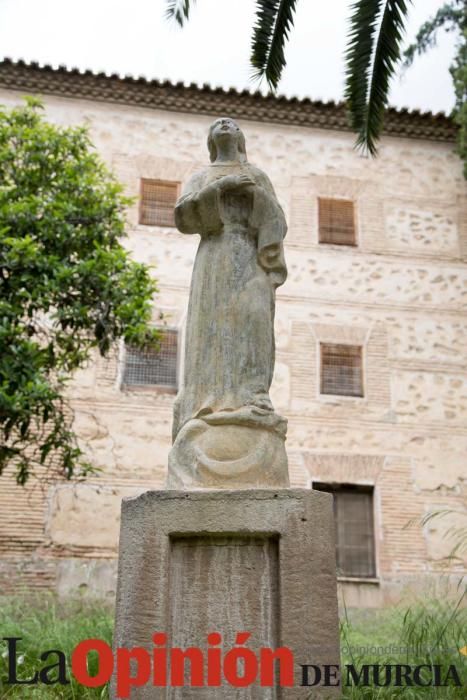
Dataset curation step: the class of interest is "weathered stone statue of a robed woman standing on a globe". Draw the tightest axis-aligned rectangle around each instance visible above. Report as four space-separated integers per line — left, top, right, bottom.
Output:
167 118 289 488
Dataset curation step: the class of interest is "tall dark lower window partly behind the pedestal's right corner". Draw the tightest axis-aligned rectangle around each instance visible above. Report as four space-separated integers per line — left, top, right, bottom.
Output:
313 483 376 578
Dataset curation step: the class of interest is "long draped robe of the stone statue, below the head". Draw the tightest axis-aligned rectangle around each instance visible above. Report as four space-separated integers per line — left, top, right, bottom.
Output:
173 162 287 440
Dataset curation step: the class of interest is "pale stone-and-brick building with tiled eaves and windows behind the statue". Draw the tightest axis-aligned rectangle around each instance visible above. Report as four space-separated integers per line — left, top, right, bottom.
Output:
0 60 467 606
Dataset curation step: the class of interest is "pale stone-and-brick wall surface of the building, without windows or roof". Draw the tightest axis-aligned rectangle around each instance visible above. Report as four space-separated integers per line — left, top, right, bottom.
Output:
0 86 467 605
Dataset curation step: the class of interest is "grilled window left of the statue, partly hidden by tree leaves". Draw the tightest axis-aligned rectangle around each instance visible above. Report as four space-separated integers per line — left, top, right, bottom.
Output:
123 328 178 389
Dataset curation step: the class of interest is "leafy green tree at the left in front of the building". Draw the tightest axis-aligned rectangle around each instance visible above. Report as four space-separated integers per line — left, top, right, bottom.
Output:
0 99 157 484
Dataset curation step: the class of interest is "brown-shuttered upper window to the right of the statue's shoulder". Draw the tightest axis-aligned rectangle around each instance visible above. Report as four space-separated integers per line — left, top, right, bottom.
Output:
318 197 357 246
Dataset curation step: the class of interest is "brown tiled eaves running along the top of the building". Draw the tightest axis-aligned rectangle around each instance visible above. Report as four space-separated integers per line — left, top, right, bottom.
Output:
0 58 457 142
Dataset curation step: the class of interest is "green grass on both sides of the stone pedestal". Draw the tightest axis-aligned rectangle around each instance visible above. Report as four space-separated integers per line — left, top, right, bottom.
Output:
0 595 467 700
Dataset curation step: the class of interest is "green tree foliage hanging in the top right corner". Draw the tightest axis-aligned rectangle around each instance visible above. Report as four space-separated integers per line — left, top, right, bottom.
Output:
404 0 467 179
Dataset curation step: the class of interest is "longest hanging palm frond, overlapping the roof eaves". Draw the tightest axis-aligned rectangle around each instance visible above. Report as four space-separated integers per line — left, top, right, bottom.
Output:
346 0 411 155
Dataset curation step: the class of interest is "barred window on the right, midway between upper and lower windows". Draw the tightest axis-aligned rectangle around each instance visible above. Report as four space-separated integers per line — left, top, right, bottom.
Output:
321 343 363 396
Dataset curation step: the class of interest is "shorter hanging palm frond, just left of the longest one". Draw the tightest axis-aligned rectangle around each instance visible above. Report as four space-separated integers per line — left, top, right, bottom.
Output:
251 0 297 90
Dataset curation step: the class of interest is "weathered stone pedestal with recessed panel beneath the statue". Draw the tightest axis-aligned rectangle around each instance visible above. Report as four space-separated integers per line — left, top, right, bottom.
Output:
112 489 339 700
